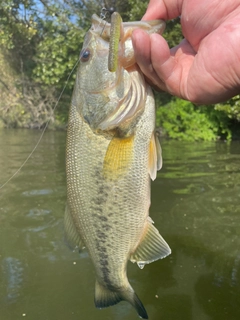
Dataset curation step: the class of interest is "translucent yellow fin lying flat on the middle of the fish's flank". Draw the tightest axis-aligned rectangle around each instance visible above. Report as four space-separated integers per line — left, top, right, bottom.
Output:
103 136 134 180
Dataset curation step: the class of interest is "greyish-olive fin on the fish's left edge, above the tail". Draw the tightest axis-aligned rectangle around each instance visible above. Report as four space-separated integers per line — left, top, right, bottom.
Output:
64 205 84 250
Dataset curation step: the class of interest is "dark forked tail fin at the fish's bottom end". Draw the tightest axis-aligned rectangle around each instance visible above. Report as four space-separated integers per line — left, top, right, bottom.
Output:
94 281 148 319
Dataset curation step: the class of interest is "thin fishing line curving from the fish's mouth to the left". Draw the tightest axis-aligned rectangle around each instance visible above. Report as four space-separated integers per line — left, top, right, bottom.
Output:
0 8 109 190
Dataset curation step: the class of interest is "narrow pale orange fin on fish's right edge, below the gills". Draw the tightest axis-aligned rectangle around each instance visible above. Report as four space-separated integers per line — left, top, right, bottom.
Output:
148 133 162 180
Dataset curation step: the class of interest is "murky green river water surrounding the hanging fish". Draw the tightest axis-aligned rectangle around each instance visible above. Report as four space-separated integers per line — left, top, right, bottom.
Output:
0 130 240 320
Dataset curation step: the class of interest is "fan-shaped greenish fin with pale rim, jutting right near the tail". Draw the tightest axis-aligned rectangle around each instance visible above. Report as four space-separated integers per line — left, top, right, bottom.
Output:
130 218 171 269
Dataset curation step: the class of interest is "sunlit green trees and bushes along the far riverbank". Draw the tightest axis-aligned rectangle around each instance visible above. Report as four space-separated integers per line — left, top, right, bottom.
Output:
0 0 240 141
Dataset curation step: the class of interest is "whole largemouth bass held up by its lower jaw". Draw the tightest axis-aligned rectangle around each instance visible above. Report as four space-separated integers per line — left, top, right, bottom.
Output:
64 14 171 319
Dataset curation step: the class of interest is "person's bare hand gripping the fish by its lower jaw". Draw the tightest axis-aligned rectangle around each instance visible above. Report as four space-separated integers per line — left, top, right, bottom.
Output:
132 0 240 104
